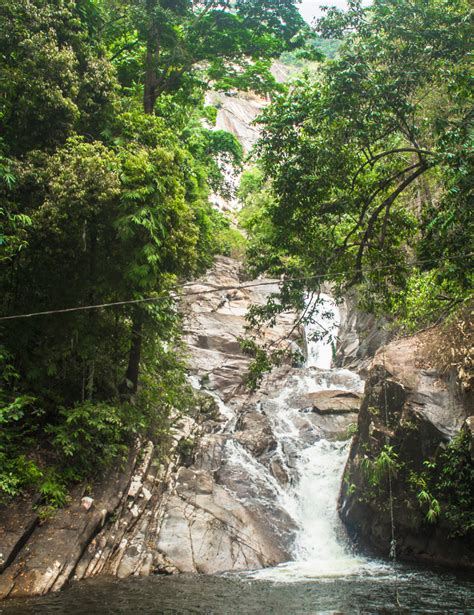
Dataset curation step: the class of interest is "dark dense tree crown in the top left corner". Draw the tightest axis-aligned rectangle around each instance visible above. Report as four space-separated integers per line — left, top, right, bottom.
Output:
0 0 117 155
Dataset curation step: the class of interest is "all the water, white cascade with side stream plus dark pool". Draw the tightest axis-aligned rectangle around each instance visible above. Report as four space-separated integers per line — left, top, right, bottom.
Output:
0 299 474 615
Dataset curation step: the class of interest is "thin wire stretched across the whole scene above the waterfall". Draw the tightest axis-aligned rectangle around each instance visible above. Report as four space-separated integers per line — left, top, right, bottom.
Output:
0 252 474 321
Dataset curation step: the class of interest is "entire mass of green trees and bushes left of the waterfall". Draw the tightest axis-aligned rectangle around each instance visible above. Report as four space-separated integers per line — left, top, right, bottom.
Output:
0 0 303 505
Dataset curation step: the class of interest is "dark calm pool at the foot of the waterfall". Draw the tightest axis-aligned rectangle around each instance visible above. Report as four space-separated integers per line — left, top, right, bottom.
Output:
0 566 474 615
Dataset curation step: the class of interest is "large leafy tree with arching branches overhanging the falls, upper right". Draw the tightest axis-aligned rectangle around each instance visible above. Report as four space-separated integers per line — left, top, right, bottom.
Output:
244 0 473 328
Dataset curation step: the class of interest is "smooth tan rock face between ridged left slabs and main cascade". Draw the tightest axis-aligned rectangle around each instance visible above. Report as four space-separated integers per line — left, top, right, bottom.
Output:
151 257 295 573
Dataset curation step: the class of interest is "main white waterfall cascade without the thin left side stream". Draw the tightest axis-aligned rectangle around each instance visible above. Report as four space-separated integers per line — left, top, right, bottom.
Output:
246 296 386 581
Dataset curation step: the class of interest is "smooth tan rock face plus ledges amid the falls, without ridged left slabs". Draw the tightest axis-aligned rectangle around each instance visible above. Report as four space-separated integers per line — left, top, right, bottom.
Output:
152 288 361 584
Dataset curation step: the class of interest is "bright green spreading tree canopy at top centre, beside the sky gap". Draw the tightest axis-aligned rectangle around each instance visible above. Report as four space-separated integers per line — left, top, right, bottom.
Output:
104 0 306 113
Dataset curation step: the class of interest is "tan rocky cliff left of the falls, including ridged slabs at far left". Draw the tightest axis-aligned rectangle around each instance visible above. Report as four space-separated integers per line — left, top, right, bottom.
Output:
0 258 291 597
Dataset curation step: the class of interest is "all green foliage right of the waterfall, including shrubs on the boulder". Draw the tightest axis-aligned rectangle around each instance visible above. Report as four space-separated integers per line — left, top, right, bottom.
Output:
239 0 474 540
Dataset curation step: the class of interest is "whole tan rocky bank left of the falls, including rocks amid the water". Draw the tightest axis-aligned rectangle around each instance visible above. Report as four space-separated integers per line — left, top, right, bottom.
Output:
0 257 360 597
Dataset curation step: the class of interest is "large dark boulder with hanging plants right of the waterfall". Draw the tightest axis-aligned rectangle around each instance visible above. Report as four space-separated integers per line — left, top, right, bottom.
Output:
339 337 474 567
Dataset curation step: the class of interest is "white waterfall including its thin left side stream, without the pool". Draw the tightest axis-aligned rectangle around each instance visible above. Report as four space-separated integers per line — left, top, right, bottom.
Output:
192 295 390 581
